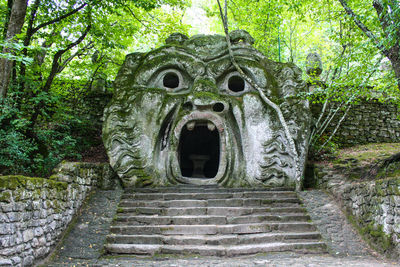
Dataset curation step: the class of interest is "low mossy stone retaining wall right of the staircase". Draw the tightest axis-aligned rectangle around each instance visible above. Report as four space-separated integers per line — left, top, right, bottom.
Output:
314 165 400 258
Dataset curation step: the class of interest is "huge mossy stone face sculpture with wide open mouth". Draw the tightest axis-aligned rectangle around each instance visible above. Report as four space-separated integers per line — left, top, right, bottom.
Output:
103 31 310 187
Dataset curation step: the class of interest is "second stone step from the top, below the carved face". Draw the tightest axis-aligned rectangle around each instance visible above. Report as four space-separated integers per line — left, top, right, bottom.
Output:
121 191 297 200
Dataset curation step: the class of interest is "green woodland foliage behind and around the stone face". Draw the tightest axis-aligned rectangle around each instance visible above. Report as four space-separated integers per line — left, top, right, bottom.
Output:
0 0 400 177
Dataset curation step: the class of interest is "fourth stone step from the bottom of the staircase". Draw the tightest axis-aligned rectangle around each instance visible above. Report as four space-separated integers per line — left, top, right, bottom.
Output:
114 213 310 225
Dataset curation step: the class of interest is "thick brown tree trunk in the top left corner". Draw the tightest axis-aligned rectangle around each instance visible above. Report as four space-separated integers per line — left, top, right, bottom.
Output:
0 0 28 98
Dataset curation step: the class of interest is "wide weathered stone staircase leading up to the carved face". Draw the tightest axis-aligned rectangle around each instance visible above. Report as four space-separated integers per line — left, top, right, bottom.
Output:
105 185 326 256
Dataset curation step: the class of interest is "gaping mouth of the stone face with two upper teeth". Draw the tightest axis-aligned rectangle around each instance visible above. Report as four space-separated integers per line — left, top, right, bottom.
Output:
167 112 228 184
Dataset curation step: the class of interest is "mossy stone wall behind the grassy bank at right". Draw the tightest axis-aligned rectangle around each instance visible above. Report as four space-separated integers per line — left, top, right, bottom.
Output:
313 99 400 146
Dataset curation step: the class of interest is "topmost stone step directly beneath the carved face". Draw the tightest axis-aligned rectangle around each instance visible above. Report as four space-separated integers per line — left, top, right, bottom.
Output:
125 185 293 193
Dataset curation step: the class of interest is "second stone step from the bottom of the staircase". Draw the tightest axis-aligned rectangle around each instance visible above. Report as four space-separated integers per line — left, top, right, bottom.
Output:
107 232 321 245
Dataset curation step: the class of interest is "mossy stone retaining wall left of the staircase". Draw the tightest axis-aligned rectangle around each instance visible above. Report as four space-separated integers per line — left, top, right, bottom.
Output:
0 162 117 266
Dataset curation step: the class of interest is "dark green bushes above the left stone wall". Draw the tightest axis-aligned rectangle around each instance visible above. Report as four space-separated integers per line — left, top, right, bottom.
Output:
0 90 95 175
